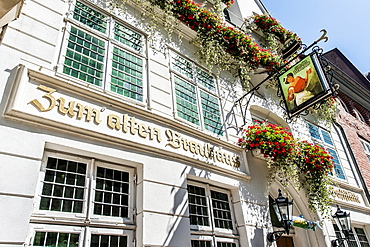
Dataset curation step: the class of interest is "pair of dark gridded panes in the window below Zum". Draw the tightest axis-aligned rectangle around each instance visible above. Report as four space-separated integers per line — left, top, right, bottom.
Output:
39 154 131 218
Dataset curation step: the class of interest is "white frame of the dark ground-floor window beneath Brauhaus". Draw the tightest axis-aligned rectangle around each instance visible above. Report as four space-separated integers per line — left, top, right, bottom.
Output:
188 180 237 235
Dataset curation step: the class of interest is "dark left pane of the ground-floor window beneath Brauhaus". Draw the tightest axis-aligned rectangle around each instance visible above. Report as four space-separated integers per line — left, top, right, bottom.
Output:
188 185 209 226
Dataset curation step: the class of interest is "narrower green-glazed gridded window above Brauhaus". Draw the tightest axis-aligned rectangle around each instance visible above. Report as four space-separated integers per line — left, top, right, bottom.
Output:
171 54 224 135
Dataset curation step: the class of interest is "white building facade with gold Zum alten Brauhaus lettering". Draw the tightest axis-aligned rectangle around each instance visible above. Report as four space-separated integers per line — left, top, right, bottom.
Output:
0 0 370 247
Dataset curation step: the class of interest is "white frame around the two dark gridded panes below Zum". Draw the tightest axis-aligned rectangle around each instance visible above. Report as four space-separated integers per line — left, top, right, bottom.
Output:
33 151 136 224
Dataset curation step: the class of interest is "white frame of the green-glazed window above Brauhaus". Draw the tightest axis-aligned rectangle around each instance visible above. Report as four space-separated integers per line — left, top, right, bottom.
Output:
169 50 226 137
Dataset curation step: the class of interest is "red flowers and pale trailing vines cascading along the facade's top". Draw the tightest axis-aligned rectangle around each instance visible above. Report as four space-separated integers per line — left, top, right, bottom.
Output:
107 0 304 86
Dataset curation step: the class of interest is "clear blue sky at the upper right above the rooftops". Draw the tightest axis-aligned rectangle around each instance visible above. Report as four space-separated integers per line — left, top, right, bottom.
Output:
262 0 370 74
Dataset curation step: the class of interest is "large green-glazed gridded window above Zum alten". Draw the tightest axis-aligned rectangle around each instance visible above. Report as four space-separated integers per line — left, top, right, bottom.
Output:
62 1 145 102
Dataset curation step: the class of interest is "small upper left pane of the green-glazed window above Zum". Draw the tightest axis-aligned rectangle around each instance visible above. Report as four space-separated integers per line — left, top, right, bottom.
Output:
73 2 107 33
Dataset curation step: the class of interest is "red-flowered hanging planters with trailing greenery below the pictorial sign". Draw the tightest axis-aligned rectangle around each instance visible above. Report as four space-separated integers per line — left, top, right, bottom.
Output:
238 122 333 213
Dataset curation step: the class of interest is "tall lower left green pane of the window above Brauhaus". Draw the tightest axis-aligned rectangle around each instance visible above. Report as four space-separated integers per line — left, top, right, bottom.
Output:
174 76 199 125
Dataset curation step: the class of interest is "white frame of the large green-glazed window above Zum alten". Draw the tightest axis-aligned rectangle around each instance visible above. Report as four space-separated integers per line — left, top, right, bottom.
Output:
56 0 148 106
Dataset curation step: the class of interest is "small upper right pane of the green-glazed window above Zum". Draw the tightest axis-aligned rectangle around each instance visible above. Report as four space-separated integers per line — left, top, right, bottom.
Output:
114 22 144 52
